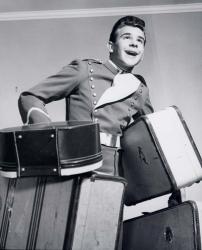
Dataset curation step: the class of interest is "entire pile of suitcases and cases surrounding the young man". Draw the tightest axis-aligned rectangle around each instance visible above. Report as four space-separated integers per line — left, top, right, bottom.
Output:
0 106 202 250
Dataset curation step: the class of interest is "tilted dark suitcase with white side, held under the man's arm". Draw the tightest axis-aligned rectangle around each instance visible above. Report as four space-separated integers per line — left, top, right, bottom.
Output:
121 106 202 205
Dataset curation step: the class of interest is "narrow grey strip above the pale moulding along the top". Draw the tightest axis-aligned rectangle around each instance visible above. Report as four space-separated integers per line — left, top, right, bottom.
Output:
0 0 200 12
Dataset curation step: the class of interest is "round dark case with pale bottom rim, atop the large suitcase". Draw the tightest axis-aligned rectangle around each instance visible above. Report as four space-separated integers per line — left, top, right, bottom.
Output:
0 121 102 178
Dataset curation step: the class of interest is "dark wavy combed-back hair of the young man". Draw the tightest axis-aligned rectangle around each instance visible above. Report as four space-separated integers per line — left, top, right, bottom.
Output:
109 16 146 42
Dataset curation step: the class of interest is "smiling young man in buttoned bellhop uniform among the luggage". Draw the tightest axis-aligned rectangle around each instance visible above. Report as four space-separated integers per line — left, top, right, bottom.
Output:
19 16 153 175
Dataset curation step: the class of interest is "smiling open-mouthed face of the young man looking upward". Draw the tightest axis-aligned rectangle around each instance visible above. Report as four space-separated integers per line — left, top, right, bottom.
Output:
109 26 145 70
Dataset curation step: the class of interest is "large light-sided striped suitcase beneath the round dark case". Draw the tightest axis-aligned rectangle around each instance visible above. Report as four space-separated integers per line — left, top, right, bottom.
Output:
0 174 125 250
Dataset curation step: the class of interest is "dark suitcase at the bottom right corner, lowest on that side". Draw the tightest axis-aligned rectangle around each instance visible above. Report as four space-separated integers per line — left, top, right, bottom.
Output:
123 201 202 250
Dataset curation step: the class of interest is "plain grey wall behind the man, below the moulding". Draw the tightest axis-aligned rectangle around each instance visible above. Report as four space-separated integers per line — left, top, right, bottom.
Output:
0 12 202 215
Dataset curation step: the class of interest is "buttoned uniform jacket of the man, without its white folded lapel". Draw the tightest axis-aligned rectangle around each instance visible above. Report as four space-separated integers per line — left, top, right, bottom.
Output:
19 59 153 134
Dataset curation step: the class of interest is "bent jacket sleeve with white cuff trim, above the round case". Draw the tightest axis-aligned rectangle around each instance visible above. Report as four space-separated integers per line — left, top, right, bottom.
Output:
18 60 87 124
